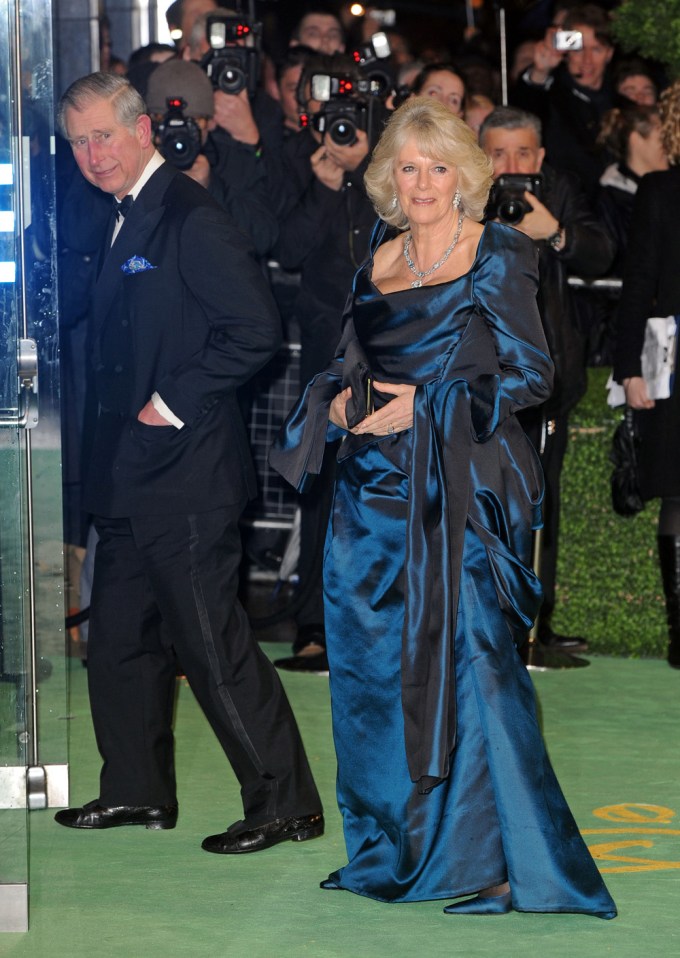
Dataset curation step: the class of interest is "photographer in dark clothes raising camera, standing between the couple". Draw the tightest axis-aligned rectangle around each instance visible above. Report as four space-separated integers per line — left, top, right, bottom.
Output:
275 48 385 672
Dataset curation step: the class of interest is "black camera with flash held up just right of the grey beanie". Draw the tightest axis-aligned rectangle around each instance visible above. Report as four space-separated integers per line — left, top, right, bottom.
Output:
201 13 262 96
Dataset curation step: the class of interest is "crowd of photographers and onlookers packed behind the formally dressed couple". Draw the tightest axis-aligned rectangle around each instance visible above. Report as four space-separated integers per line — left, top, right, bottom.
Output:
59 0 680 670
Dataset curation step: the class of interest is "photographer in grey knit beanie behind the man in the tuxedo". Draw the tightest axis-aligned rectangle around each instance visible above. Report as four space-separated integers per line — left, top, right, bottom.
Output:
146 60 278 256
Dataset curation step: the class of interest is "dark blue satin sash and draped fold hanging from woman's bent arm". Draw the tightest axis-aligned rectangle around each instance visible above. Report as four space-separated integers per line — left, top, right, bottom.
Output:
402 314 543 793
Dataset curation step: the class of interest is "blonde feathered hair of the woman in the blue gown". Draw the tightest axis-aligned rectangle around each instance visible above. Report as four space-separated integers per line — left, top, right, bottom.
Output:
364 97 493 229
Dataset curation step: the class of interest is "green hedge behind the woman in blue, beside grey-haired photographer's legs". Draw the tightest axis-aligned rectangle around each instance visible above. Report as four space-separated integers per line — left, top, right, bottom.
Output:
553 369 668 658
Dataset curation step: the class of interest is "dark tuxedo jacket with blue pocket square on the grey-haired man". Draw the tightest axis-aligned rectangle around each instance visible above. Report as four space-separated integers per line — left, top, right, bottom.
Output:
85 163 281 517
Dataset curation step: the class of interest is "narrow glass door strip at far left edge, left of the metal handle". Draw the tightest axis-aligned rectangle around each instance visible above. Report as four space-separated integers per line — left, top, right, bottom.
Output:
0 0 28 931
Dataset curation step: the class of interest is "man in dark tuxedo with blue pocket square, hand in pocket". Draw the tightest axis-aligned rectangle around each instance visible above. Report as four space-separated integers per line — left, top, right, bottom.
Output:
56 73 324 854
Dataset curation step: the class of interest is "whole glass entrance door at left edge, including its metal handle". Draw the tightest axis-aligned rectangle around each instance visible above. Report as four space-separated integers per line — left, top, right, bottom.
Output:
0 0 67 931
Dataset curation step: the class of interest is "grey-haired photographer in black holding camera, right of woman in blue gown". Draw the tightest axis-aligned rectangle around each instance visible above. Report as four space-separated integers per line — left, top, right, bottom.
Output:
479 107 614 652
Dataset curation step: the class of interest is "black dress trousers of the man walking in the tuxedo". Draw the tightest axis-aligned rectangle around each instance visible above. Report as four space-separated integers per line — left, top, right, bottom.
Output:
88 505 321 825
